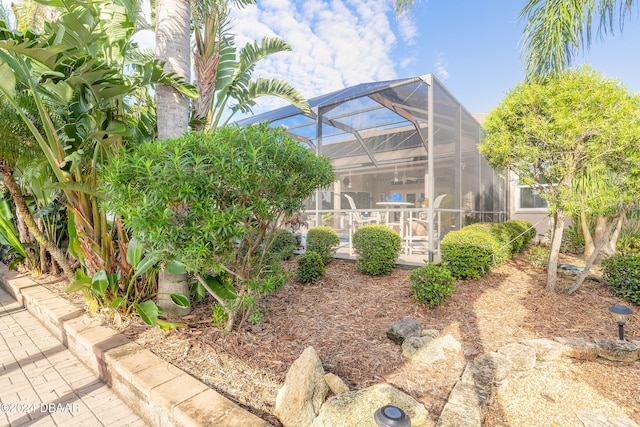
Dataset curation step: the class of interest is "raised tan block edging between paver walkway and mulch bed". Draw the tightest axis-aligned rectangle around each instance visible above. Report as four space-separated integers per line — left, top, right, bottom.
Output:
0 263 271 427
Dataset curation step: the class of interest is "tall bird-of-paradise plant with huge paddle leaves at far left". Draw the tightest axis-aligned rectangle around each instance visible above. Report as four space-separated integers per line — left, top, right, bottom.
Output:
0 0 195 324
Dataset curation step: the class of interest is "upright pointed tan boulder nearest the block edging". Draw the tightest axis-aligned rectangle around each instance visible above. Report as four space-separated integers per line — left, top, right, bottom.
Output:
275 347 329 427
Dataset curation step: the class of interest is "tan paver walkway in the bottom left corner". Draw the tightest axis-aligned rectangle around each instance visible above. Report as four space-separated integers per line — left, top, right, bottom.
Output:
0 287 147 427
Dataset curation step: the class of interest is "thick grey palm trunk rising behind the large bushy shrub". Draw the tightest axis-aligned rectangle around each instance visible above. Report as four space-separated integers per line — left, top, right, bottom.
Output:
156 0 191 316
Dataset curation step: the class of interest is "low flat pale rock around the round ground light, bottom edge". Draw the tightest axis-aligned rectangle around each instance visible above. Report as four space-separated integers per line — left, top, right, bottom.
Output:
311 384 433 427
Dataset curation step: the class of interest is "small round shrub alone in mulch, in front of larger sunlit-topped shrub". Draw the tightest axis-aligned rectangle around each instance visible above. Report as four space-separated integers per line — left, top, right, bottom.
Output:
409 261 456 308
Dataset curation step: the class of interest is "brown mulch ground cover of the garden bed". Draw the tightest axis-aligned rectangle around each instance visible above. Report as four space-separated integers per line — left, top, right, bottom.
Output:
33 255 640 426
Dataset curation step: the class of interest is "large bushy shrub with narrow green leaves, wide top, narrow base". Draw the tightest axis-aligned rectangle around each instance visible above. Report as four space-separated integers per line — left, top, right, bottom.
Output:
105 125 334 330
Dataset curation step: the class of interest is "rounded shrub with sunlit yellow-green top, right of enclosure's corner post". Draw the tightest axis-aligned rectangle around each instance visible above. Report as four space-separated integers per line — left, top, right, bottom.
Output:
440 226 500 279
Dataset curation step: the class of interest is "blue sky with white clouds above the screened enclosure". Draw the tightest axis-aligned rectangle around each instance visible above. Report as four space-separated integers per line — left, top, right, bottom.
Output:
2 0 640 113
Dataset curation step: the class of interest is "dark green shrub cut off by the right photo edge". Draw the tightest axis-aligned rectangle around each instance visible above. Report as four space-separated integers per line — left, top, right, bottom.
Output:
602 254 640 304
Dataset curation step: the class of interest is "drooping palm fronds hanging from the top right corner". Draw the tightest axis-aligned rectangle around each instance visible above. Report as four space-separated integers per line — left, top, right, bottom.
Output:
520 0 633 80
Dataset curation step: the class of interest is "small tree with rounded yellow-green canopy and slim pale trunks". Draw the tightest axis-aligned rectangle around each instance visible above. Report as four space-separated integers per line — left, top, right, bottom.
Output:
480 68 640 292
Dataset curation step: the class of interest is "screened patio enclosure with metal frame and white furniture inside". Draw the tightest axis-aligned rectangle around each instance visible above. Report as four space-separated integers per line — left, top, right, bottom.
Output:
238 74 509 261
